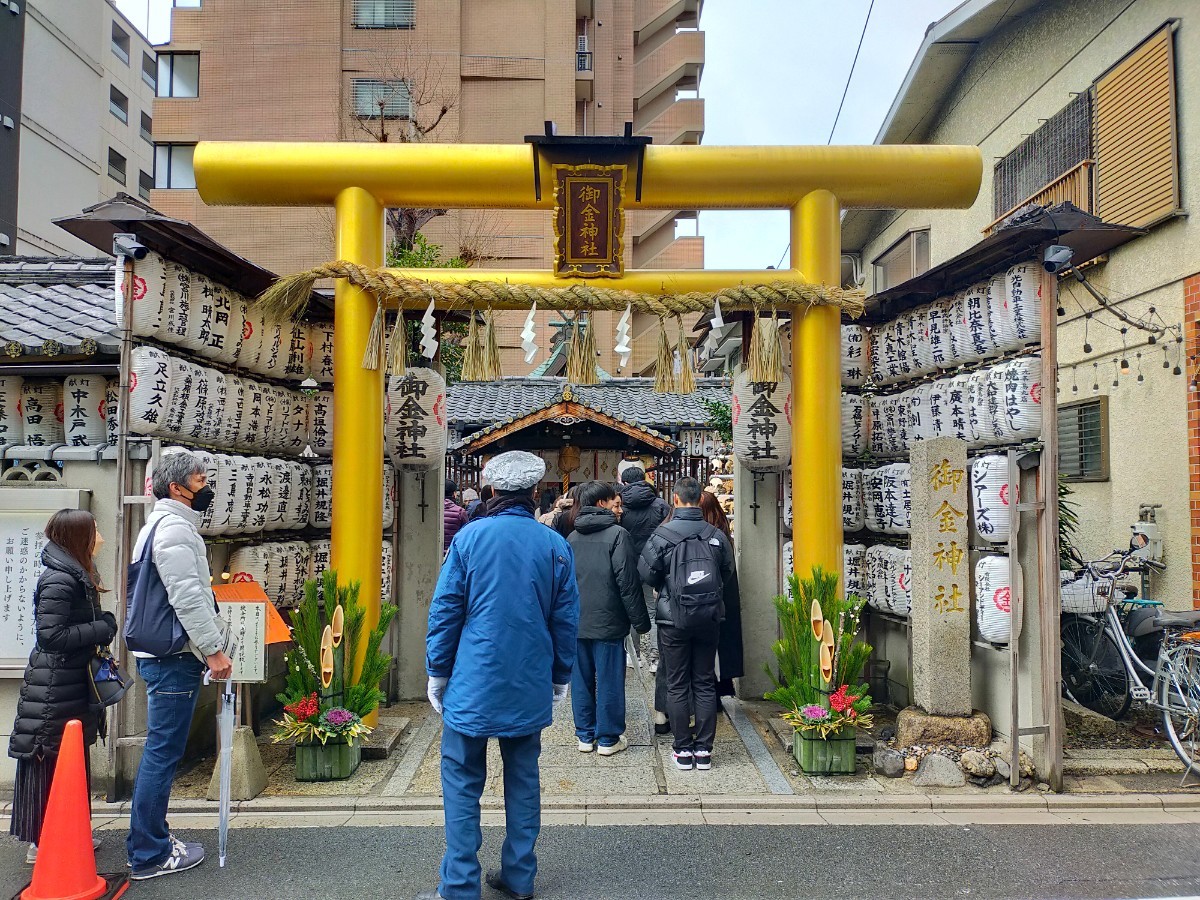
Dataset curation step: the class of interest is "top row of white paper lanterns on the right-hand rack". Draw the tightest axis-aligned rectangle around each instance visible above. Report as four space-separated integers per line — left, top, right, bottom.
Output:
864 262 1042 384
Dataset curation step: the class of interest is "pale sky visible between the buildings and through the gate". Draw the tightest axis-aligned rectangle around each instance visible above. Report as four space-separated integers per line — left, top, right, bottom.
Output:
115 0 960 269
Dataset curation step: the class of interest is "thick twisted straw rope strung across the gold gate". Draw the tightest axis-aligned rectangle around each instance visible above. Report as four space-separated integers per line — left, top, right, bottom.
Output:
258 260 866 320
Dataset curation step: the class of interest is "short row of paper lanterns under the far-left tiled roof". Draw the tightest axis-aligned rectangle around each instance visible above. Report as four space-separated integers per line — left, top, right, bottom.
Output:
0 374 118 446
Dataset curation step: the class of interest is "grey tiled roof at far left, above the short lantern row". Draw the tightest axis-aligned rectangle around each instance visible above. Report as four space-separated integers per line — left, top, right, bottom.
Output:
0 257 120 360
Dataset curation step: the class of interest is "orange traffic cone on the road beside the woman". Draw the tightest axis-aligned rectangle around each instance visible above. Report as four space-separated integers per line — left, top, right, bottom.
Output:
13 719 128 900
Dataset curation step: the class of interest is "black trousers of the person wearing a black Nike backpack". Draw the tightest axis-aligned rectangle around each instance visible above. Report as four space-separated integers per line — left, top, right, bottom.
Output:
659 625 720 752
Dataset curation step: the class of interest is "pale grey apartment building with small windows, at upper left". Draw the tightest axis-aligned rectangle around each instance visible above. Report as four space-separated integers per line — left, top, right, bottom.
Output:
0 0 157 256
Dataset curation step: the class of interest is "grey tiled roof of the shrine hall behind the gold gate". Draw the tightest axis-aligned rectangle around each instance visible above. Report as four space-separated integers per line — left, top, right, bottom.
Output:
446 378 730 431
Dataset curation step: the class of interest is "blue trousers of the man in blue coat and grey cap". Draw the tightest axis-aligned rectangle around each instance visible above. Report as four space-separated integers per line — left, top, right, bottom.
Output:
438 725 541 900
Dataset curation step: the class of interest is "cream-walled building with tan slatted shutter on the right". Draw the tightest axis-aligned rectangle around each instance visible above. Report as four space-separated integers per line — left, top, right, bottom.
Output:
842 0 1200 607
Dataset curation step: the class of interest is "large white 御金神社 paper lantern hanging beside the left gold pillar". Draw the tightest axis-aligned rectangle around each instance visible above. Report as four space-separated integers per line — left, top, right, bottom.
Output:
384 368 446 470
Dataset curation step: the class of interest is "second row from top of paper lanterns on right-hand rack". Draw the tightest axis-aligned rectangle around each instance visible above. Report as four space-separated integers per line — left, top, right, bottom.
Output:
842 356 1042 456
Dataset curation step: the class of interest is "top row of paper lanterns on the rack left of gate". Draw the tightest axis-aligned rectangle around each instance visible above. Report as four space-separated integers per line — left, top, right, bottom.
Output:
115 253 334 383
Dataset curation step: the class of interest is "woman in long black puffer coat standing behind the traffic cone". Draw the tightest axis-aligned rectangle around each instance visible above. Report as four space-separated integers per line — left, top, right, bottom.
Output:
8 510 116 863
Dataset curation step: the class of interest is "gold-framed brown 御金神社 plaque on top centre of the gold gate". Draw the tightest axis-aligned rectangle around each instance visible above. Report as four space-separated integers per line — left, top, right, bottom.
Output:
554 166 628 278
